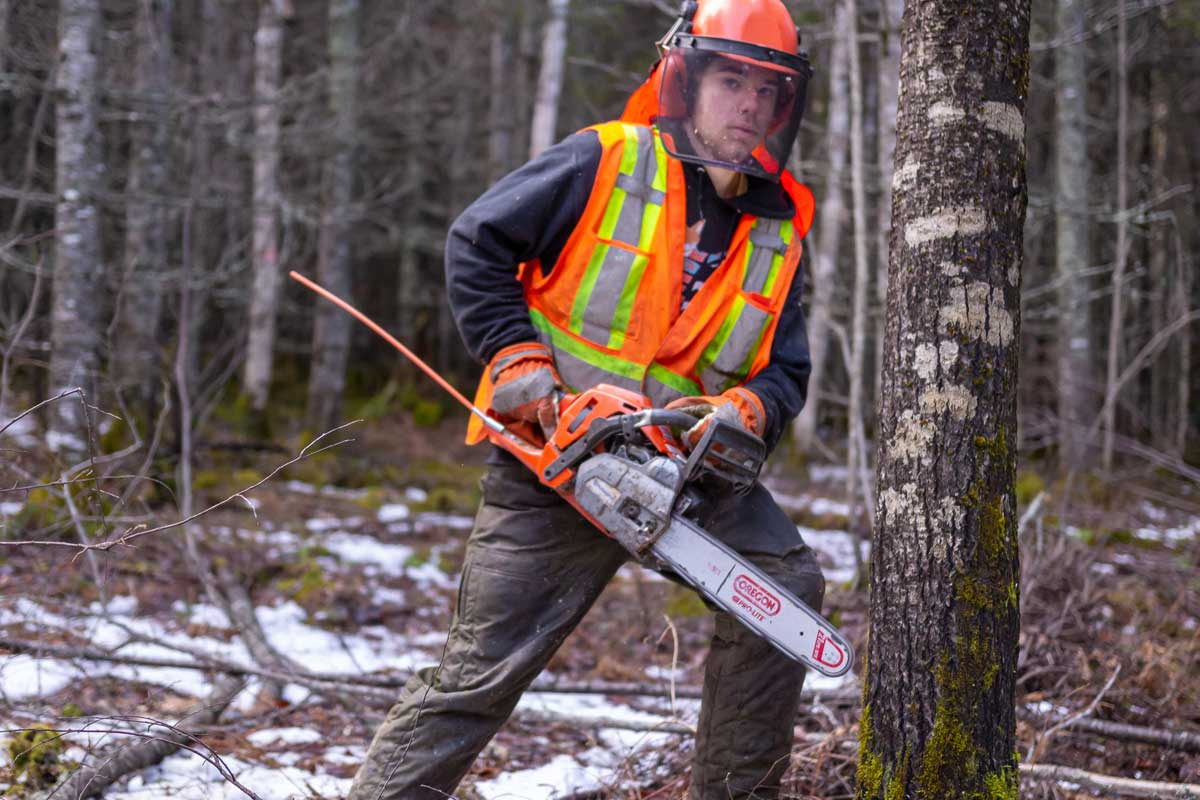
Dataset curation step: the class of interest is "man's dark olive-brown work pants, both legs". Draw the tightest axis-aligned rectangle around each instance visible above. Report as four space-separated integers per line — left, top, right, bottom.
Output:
349 467 824 800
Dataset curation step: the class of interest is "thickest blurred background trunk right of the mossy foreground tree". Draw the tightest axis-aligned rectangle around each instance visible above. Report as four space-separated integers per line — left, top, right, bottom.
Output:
1055 0 1096 468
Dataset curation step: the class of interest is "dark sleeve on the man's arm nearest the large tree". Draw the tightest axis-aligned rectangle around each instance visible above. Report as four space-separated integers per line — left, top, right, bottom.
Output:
745 251 812 450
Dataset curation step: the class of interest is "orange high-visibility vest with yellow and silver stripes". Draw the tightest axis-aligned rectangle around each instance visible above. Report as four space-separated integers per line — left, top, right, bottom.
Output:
468 121 814 443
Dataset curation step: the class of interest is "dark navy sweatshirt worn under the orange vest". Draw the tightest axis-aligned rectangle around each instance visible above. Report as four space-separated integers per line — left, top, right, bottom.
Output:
445 131 811 447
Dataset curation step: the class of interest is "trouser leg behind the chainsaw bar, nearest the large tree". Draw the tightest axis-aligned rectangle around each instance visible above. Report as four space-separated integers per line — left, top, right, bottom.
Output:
689 485 824 800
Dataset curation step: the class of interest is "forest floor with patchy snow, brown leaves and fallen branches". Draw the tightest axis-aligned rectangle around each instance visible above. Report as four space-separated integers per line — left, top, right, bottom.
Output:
0 410 1200 800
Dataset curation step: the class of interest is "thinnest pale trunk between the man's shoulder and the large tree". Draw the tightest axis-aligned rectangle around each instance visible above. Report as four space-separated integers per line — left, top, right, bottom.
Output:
846 0 871 529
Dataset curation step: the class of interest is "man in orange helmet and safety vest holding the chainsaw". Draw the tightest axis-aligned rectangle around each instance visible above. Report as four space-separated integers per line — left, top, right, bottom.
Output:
350 0 824 800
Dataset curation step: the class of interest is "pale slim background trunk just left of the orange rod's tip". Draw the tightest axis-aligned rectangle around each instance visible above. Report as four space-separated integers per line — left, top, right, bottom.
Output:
242 0 283 414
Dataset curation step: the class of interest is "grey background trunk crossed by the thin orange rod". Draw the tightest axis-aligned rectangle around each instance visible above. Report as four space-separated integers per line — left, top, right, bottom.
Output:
308 0 360 432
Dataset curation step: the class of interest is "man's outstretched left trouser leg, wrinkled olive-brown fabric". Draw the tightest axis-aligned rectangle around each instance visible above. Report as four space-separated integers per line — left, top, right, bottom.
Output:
349 467 626 800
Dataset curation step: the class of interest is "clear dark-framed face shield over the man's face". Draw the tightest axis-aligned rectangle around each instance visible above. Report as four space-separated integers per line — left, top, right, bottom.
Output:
655 34 811 180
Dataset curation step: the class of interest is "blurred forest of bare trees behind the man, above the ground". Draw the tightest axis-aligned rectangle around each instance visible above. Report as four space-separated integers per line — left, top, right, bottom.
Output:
0 0 1200 476
